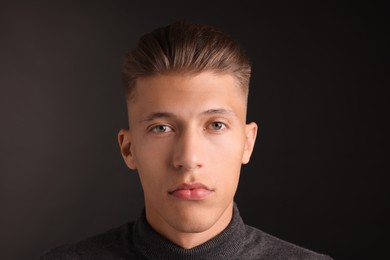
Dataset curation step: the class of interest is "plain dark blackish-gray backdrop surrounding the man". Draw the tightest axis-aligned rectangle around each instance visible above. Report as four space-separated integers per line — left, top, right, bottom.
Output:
0 0 390 259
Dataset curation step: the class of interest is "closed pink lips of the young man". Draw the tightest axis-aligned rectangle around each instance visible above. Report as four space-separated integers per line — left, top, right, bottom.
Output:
168 183 213 200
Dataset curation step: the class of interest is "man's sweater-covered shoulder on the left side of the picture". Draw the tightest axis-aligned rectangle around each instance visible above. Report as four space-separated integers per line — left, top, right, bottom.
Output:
38 223 139 260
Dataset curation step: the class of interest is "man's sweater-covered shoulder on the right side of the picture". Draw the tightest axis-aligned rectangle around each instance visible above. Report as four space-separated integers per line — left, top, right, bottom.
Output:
241 225 332 260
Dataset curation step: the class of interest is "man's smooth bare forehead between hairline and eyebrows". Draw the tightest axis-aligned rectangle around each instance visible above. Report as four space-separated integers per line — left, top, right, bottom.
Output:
128 72 246 123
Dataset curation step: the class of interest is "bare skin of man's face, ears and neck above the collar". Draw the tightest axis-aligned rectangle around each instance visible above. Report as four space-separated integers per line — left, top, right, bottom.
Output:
118 72 257 249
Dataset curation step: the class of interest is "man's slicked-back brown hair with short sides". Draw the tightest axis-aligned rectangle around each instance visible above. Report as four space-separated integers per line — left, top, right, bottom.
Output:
122 21 251 99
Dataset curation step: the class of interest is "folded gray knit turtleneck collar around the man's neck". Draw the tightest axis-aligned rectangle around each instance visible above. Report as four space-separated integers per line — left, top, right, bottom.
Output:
133 204 245 260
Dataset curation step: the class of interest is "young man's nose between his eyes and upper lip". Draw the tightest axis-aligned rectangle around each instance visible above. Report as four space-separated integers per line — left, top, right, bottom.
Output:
173 129 204 171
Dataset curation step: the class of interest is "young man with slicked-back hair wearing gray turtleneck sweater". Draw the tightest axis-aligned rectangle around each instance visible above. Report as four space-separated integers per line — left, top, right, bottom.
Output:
38 22 331 259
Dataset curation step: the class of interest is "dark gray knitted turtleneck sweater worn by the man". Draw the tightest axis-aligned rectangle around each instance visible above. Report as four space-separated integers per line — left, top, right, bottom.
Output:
39 205 332 260
